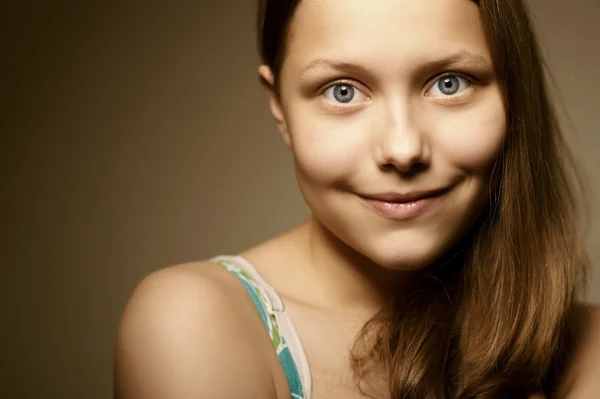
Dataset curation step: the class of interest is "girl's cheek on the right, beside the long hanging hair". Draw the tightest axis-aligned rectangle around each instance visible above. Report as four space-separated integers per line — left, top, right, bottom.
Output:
436 103 506 173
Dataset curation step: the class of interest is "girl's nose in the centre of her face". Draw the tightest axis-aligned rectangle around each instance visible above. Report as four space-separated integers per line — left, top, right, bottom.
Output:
378 106 431 173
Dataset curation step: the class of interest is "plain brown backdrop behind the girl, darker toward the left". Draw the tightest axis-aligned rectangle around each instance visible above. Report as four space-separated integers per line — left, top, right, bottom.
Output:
0 0 600 399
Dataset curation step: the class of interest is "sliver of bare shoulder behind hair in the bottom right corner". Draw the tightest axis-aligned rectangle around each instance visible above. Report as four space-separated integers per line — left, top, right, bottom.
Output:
557 305 600 399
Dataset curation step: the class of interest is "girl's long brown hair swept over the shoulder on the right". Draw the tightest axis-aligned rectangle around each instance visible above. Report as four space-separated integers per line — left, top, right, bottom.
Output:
258 0 588 399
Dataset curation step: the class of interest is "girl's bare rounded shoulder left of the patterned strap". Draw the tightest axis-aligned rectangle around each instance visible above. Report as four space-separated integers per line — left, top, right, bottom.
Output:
115 262 277 399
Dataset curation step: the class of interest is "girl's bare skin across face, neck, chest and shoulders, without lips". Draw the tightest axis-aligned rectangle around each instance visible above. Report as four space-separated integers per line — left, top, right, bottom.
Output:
115 0 600 399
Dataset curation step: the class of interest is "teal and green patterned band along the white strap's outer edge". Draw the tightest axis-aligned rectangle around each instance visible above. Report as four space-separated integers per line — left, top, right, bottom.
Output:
214 259 304 399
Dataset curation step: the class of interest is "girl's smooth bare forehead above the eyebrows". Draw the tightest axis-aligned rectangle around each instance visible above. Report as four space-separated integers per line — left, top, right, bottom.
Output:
286 0 489 72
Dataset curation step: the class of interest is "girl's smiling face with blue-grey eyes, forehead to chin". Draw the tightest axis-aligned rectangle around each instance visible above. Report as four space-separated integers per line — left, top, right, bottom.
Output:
260 0 506 269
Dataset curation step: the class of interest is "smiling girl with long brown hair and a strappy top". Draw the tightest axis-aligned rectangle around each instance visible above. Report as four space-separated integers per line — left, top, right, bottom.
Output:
116 0 600 399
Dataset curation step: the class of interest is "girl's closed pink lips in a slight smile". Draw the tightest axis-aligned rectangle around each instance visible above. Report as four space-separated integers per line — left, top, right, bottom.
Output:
360 188 450 220
